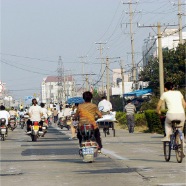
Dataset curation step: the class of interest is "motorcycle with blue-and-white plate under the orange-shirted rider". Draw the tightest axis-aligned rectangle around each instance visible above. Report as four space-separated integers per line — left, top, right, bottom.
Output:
79 124 98 163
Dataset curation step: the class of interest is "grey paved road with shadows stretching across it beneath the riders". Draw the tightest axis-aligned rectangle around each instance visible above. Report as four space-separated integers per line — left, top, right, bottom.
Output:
0 123 186 186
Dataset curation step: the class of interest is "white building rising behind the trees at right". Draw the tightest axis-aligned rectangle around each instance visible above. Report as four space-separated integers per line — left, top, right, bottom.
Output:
142 29 186 66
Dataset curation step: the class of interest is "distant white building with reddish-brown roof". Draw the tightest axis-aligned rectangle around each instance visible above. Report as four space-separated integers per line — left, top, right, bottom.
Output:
41 76 75 104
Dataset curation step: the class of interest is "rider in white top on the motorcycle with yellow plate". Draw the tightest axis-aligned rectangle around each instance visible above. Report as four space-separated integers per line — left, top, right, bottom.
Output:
27 98 43 133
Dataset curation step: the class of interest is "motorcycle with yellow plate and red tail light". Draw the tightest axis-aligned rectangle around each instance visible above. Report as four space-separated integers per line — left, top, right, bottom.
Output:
27 121 43 141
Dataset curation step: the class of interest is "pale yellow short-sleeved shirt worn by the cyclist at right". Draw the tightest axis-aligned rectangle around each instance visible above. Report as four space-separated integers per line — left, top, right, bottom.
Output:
160 90 185 113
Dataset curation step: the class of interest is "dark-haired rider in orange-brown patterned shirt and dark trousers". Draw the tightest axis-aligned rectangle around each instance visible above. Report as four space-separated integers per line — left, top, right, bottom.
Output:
74 91 102 152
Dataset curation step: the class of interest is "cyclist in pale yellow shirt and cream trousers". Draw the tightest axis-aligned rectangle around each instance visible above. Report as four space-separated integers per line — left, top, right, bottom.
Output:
156 82 186 141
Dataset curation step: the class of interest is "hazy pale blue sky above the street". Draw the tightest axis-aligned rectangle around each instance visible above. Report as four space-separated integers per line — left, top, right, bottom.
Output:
0 0 186 99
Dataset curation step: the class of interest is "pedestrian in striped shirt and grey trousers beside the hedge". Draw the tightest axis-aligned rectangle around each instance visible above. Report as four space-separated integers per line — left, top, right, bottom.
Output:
124 99 136 133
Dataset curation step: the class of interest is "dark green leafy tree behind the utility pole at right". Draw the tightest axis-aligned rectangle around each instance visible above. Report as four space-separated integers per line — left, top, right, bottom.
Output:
139 43 186 95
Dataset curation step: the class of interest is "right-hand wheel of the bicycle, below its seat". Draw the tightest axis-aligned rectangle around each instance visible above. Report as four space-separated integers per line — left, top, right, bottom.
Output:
175 132 183 163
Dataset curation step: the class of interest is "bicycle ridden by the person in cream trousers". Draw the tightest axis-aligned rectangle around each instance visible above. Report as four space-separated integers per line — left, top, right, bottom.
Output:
163 120 184 163
